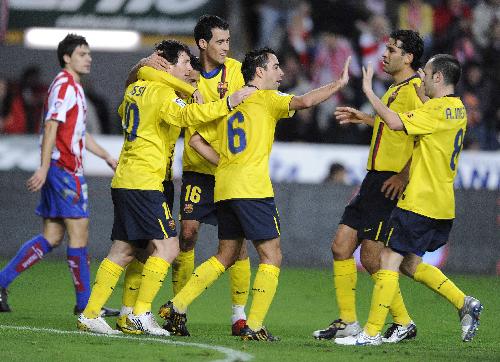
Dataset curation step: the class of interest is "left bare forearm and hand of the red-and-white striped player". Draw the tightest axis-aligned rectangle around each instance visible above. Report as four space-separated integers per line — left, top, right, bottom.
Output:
26 119 59 192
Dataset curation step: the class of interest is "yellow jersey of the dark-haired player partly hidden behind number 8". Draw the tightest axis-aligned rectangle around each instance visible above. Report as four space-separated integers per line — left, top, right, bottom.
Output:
366 75 422 172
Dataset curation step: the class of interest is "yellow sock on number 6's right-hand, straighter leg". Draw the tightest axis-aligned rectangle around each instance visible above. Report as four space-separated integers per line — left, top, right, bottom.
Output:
247 264 280 331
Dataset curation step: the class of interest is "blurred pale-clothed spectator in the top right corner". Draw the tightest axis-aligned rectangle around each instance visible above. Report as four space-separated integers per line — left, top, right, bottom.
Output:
472 0 500 49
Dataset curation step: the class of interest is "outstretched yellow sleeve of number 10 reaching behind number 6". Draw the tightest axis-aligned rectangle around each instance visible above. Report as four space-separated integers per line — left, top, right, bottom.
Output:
160 97 228 127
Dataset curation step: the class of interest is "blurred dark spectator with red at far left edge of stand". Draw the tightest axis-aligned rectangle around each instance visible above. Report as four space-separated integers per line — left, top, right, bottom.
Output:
3 65 48 134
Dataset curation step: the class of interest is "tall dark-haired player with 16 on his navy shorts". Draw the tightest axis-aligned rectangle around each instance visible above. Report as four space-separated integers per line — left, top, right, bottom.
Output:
132 15 250 335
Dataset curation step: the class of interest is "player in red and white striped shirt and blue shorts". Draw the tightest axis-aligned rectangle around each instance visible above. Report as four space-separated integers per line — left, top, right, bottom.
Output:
0 34 117 314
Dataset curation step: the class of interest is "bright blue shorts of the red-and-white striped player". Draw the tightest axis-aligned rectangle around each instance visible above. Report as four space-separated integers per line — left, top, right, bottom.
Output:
35 162 89 219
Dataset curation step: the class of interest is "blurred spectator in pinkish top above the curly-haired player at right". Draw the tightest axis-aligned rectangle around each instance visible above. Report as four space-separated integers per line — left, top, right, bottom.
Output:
398 0 434 58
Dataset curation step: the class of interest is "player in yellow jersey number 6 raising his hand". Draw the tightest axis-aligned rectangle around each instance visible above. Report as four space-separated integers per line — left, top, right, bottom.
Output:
159 48 350 341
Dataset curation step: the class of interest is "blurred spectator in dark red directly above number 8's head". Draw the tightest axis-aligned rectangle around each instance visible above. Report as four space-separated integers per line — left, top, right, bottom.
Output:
433 0 472 54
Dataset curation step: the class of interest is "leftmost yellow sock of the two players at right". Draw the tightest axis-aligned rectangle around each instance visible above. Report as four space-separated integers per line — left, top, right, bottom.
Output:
333 258 358 323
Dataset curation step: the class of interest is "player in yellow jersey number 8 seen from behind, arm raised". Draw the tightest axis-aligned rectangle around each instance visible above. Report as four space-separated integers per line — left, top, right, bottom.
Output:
335 54 483 346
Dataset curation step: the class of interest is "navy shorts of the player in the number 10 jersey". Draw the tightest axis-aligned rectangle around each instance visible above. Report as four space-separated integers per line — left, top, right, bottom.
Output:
111 188 177 247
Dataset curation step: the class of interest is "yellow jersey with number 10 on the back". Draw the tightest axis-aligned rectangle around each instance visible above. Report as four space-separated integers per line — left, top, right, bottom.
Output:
111 79 228 191
